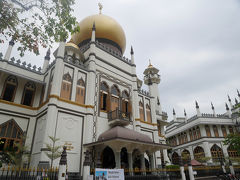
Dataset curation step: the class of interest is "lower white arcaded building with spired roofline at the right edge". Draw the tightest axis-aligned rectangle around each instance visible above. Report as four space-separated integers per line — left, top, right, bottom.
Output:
165 97 240 165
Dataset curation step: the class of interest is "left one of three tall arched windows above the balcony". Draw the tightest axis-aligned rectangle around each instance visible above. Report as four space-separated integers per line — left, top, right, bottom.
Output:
100 82 110 111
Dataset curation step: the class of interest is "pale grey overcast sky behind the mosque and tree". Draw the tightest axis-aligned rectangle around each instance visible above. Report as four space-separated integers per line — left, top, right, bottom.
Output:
1 0 240 120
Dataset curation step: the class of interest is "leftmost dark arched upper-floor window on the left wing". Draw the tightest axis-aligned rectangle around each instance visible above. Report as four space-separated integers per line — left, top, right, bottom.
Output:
1 76 18 102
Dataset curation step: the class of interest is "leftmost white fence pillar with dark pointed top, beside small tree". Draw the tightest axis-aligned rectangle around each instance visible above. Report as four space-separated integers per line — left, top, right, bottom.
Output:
58 146 67 180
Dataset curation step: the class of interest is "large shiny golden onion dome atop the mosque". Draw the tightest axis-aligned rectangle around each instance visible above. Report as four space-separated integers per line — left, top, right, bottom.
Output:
71 14 126 54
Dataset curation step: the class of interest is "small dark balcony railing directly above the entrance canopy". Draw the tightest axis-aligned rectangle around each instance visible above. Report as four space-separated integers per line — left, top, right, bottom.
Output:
108 109 131 126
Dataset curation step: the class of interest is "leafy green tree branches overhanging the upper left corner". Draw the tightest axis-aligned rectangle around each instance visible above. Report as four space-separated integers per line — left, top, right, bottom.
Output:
0 0 80 56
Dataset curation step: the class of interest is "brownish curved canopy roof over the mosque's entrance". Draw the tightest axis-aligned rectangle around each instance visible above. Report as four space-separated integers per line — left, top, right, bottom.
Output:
84 126 171 152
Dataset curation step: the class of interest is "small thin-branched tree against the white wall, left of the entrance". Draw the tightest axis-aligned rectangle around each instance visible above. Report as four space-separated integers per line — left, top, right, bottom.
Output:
45 136 62 168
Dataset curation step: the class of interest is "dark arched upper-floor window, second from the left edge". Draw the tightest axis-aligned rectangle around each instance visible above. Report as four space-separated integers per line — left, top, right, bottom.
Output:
22 82 36 106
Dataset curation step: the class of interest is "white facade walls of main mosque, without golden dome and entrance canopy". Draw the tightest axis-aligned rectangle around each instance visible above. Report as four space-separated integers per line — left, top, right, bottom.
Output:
0 11 169 173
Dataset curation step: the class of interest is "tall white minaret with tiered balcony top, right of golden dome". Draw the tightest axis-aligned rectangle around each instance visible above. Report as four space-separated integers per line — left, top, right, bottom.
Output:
143 60 162 114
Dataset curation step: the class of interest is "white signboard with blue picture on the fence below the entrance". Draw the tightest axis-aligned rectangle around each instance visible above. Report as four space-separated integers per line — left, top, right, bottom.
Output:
95 168 124 180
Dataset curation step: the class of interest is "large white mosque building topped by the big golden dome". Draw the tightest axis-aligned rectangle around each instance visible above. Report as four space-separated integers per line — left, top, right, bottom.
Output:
0 7 170 174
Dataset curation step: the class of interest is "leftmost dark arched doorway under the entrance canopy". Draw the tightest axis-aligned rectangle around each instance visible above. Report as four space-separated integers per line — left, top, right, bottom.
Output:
102 146 116 169
